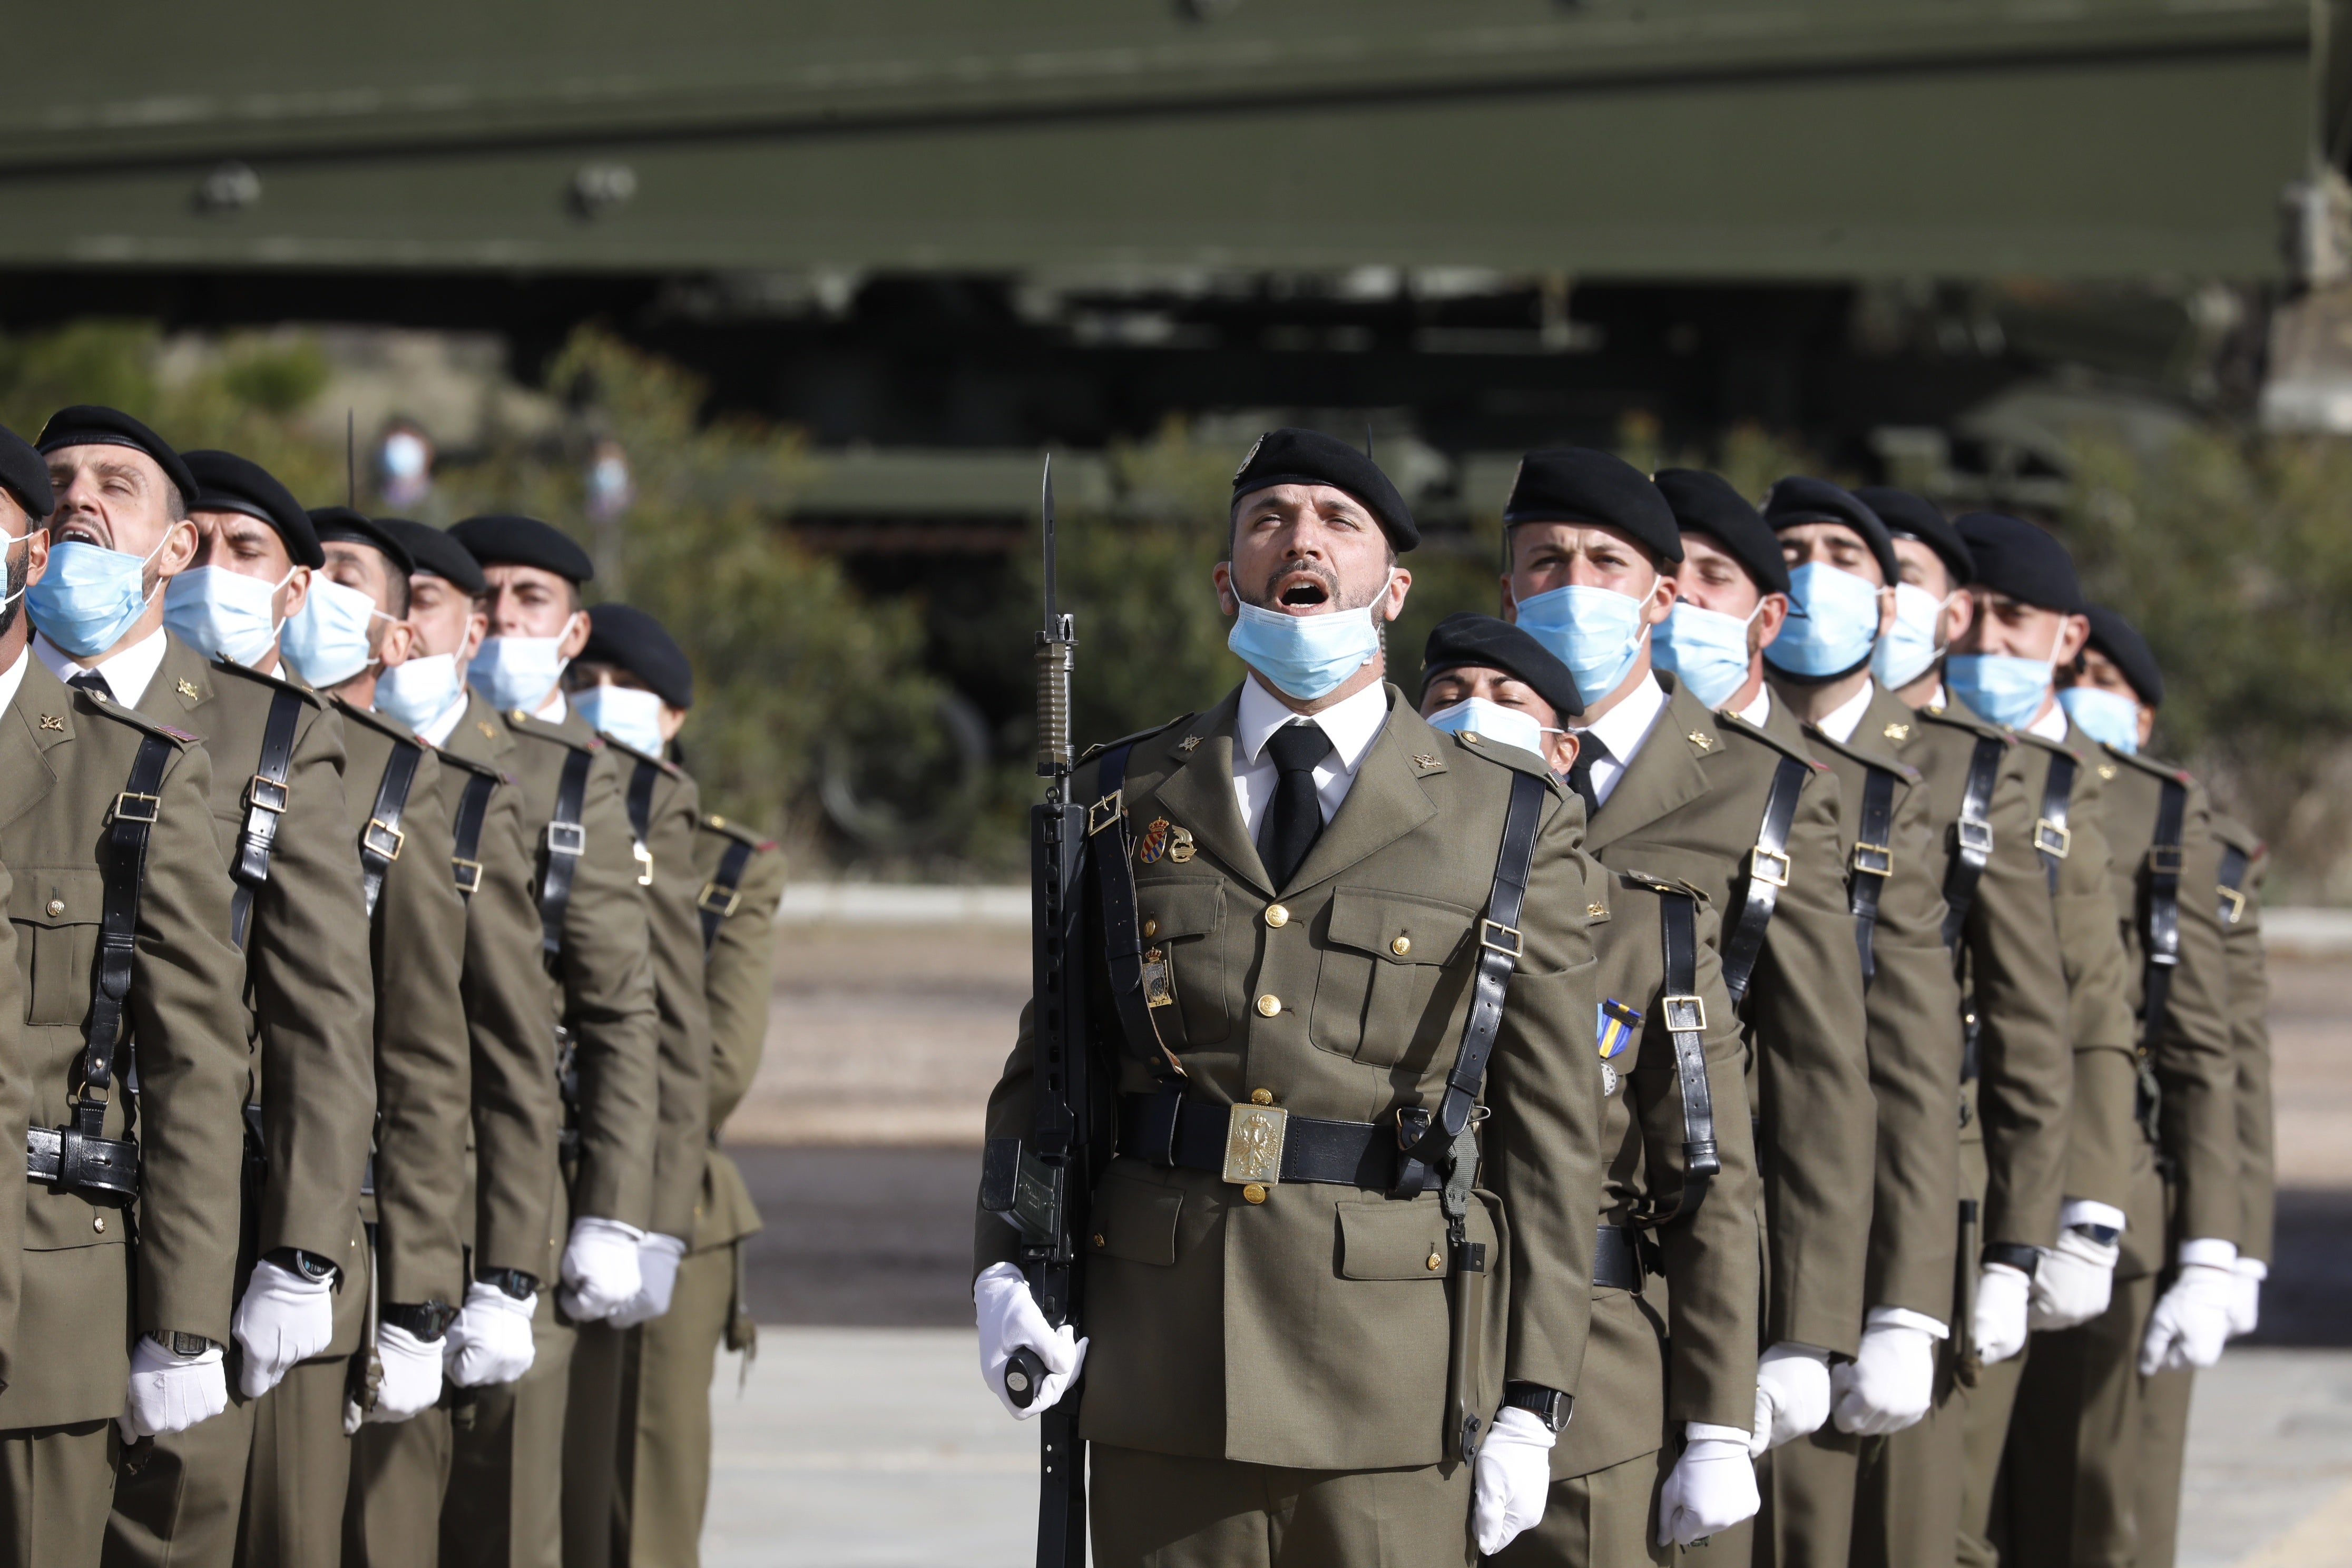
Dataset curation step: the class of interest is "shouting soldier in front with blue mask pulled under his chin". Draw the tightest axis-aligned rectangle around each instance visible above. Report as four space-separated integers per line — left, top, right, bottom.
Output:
974 430 1606 1568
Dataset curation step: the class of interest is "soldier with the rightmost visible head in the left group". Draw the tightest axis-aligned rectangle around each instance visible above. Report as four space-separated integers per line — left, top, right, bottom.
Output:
564 604 710 1568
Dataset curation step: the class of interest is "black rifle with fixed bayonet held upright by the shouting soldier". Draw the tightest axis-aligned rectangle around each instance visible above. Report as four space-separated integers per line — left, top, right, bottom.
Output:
981 458 1089 1568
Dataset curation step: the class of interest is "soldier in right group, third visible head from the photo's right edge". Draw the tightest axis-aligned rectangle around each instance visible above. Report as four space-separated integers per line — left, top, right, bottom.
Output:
1854 487 2074 1566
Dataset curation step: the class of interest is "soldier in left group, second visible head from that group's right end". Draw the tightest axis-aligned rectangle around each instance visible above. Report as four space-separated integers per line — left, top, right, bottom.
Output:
442 517 661 1568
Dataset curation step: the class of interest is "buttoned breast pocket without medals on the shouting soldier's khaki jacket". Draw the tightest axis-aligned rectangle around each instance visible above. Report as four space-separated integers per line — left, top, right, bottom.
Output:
1308 889 1477 1067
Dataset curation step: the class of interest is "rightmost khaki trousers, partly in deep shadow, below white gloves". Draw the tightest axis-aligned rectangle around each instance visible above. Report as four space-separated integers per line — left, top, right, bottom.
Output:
1992 1274 2157 1568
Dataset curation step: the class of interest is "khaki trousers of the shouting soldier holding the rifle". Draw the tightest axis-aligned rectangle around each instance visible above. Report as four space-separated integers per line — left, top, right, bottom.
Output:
1086 1444 1477 1568
